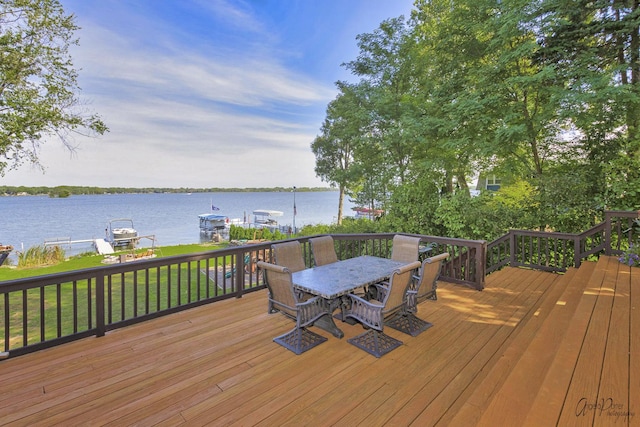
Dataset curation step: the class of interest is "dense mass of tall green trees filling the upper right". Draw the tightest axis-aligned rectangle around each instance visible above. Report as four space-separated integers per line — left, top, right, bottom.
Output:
314 0 640 240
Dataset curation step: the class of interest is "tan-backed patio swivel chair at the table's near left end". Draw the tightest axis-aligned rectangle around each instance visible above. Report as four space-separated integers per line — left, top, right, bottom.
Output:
258 261 330 354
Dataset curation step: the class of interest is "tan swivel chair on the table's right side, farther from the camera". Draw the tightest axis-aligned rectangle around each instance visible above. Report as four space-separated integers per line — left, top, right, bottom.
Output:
384 252 449 337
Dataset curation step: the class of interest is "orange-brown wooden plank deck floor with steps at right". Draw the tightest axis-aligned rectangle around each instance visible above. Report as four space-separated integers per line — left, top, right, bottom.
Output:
0 257 640 426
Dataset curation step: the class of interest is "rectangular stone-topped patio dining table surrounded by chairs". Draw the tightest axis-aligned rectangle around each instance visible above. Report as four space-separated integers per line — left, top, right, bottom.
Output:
292 255 406 338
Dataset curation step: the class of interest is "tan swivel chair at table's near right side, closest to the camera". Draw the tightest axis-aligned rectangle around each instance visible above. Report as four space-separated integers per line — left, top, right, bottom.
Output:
344 261 420 357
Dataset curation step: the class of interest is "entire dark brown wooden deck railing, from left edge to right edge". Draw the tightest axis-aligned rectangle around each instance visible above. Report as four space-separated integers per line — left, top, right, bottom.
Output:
0 212 638 358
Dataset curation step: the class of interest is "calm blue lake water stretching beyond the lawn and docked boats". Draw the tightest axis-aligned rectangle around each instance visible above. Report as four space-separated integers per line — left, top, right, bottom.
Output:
0 191 353 253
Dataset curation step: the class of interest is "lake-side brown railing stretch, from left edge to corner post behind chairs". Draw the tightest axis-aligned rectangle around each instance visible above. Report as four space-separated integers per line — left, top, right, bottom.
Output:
0 234 485 357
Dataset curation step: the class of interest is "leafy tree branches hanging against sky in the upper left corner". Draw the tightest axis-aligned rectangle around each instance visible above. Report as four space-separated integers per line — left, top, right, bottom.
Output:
0 0 107 176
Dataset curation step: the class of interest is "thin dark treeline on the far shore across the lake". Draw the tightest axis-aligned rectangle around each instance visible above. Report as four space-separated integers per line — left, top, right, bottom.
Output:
0 185 335 197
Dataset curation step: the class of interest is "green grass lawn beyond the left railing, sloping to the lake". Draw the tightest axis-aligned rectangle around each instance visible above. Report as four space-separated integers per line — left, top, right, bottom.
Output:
0 243 252 351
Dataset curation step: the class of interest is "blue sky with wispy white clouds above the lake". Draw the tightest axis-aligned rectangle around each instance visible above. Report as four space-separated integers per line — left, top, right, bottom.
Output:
0 0 412 188
